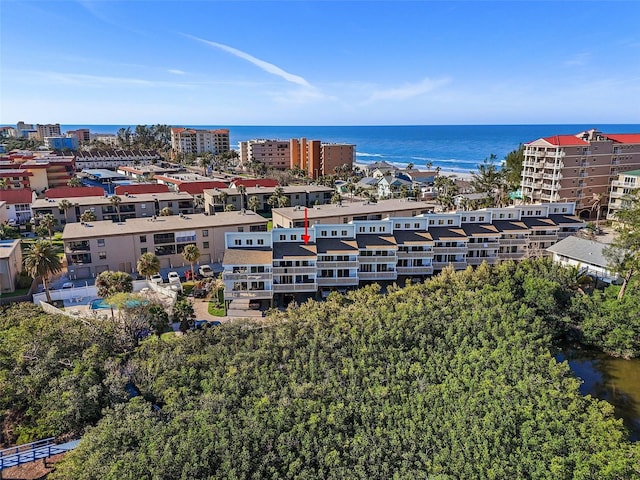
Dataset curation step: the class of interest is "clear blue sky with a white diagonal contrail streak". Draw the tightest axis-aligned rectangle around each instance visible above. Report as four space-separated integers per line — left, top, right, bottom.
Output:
0 0 640 125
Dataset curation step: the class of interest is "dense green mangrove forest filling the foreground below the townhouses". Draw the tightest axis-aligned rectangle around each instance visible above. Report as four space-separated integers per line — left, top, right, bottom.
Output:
0 260 640 479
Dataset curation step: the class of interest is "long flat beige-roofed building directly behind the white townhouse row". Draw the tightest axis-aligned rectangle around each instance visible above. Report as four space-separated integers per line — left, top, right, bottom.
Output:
273 199 435 228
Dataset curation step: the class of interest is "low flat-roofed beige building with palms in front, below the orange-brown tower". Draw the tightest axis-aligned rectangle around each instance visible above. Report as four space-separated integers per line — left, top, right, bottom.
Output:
204 185 334 213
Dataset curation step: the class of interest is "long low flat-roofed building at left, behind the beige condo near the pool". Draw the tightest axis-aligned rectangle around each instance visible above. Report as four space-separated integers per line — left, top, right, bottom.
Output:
31 191 195 228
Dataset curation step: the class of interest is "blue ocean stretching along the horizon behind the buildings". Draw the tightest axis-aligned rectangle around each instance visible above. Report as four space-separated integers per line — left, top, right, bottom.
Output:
61 124 640 173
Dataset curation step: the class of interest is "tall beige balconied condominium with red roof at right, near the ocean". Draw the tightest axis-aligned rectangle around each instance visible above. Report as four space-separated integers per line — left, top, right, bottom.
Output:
521 130 640 218
